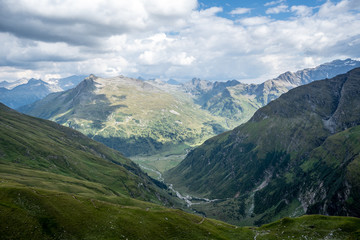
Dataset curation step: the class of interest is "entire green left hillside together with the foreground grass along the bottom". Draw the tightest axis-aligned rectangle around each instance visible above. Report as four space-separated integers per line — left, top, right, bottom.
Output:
0 101 360 239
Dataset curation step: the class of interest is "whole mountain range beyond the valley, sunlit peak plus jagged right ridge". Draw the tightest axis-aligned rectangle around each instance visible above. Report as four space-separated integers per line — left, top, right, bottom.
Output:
20 59 360 166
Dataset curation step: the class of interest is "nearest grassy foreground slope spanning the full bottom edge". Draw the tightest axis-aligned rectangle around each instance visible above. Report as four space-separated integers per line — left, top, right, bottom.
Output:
0 181 360 240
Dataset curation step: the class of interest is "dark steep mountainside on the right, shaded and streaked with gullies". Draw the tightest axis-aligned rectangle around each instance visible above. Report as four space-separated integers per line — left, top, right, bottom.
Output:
165 68 360 225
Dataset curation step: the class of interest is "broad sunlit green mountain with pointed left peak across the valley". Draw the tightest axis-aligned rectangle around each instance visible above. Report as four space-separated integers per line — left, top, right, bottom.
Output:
23 76 224 156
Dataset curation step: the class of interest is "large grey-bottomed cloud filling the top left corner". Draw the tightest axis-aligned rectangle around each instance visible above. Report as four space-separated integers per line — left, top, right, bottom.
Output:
0 0 197 45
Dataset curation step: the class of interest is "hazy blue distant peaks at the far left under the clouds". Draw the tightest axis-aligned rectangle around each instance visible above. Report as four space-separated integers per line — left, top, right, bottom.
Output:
0 76 85 108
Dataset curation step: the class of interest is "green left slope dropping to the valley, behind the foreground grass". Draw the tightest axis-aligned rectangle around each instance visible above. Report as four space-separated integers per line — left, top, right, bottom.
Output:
0 104 174 202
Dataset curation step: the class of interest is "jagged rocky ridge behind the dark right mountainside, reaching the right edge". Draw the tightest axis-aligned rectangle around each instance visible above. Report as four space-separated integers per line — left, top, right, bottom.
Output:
183 59 360 125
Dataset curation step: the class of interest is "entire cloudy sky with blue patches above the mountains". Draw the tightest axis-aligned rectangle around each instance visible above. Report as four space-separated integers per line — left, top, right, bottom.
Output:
0 0 360 83
